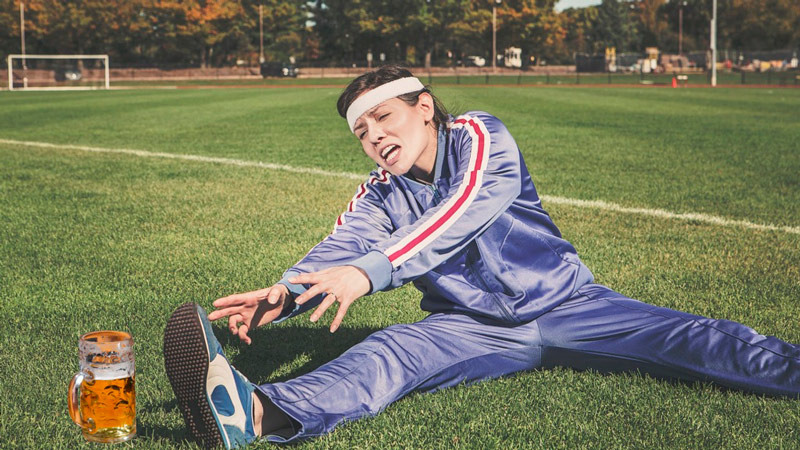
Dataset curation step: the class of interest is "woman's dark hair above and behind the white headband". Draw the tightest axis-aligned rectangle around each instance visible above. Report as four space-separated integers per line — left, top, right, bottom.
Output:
336 64 447 128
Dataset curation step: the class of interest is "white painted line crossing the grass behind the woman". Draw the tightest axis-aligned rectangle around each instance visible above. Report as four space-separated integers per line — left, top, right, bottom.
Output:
0 139 800 235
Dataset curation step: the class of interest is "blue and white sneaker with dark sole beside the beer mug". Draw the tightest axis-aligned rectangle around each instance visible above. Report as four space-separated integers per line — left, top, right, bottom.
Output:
164 303 257 448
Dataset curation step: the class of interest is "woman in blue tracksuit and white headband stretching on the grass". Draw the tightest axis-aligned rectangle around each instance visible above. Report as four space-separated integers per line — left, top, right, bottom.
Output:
165 66 800 447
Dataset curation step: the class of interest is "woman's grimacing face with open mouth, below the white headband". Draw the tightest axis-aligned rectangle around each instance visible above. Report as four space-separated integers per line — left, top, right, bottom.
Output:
353 93 437 182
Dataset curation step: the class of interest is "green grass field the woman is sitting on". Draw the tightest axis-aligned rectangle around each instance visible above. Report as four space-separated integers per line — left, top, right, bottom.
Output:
0 86 800 449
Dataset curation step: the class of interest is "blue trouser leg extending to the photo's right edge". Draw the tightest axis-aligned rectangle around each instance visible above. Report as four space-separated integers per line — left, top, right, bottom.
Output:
536 285 800 397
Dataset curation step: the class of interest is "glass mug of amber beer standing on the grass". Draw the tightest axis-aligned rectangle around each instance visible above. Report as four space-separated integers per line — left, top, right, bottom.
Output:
68 331 136 443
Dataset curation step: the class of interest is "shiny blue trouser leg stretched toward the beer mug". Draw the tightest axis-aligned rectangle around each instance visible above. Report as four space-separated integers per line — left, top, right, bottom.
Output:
258 314 541 442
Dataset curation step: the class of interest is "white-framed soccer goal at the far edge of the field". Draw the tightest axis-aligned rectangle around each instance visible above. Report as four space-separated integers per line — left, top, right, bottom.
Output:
8 55 110 91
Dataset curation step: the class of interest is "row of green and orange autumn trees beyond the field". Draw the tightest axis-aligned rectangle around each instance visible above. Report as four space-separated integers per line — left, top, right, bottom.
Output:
0 0 800 67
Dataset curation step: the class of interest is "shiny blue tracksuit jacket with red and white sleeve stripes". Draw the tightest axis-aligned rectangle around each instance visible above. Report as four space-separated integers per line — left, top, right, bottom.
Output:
281 111 592 323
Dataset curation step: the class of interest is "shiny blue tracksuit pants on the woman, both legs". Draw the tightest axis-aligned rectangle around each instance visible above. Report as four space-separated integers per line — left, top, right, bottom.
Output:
259 284 800 442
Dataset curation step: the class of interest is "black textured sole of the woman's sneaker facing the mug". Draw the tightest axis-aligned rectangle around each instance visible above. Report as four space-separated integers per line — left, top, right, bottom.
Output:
164 303 224 448
